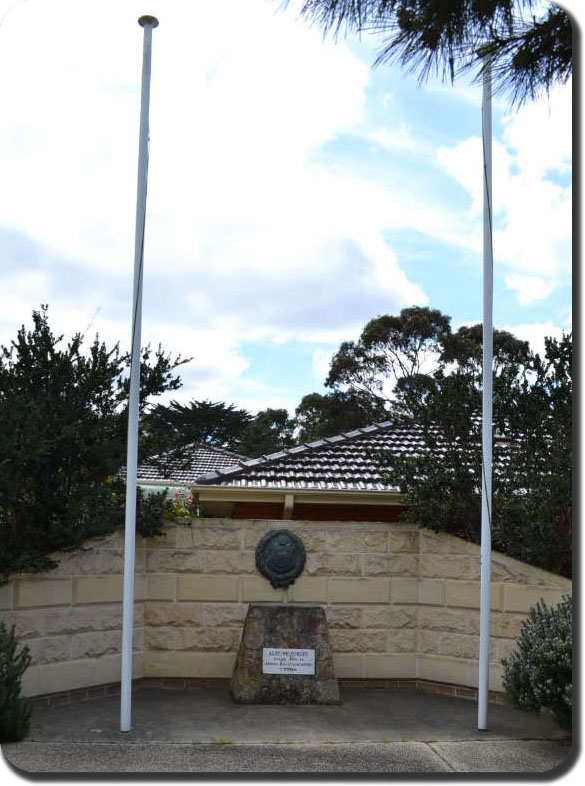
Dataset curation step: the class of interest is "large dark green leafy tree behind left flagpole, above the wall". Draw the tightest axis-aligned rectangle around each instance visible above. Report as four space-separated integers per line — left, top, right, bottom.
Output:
0 306 185 577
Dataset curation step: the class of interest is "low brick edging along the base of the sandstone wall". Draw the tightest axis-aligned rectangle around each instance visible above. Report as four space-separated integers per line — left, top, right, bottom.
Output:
25 677 509 708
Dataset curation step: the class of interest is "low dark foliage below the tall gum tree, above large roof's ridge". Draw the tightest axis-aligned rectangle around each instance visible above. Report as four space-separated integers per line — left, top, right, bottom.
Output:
295 390 388 442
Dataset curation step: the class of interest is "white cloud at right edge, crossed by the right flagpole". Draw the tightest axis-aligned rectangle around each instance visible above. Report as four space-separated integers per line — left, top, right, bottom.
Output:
437 79 572 306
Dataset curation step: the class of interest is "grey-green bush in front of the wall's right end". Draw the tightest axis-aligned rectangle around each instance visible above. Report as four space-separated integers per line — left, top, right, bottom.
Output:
503 596 573 731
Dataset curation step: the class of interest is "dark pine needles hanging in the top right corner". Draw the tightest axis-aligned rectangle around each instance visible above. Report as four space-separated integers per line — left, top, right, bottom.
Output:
290 0 572 104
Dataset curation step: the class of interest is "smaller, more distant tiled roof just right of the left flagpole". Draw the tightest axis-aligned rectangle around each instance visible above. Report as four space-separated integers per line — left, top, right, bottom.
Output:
138 445 247 485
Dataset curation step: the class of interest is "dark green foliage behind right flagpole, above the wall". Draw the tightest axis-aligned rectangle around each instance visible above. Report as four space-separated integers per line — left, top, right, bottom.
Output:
382 326 572 576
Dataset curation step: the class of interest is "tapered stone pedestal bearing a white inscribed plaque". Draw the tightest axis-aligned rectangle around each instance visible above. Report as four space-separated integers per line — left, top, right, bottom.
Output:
231 603 340 704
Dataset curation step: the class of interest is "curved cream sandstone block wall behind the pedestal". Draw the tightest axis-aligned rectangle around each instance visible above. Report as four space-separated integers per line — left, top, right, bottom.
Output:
0 518 571 695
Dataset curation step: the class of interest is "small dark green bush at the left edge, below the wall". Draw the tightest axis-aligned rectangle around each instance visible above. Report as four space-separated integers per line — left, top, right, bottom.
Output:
0 622 31 742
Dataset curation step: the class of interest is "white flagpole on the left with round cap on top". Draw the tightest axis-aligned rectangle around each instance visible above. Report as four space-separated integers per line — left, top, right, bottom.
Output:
120 16 158 731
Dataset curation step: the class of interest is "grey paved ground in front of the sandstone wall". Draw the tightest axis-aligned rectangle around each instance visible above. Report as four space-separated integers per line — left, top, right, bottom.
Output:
2 688 571 773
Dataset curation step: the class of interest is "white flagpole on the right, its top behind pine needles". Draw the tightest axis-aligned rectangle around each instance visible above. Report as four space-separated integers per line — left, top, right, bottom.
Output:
477 51 494 730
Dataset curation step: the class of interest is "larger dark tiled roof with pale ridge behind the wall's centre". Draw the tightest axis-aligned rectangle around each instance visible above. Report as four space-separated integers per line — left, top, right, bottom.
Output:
198 421 434 491
